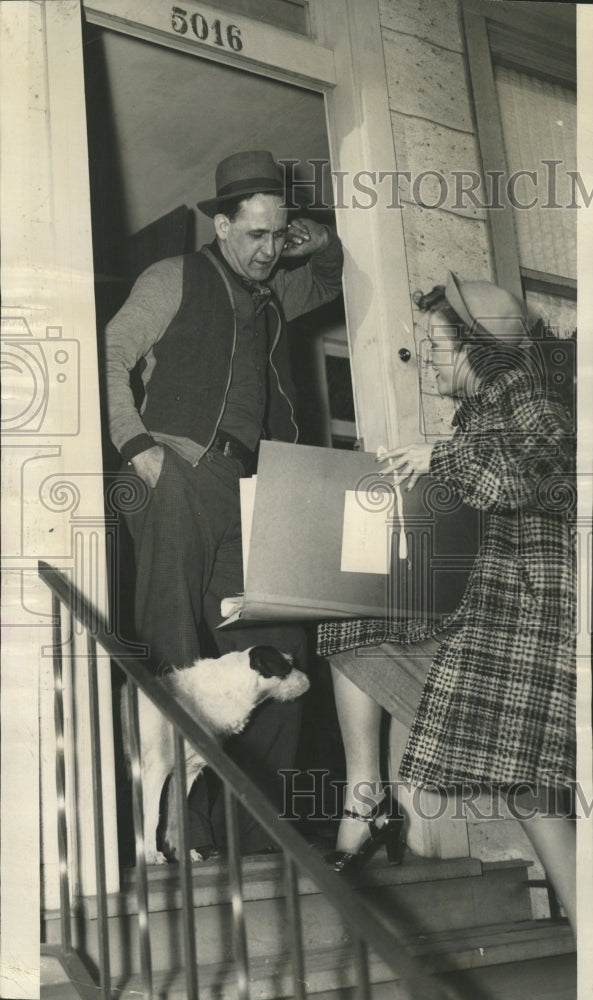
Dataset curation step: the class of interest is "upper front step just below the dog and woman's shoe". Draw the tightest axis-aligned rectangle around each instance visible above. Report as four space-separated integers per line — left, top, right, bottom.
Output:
41 855 531 977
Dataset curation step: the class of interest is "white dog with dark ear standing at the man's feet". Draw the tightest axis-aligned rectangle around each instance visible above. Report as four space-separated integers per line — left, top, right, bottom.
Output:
121 646 309 864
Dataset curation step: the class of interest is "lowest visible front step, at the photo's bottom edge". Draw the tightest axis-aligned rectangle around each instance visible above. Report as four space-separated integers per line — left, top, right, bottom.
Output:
113 921 576 1000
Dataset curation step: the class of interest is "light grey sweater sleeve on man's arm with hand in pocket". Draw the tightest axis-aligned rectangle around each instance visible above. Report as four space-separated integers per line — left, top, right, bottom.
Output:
105 257 183 460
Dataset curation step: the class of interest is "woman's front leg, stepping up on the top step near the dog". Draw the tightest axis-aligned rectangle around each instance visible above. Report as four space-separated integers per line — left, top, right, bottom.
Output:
331 666 383 854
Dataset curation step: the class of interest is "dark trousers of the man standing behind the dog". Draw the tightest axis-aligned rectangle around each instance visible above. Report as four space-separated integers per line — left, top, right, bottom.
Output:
120 448 306 853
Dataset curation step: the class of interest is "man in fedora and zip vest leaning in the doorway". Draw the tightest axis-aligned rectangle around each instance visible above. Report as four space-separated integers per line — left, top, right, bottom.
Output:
106 151 342 853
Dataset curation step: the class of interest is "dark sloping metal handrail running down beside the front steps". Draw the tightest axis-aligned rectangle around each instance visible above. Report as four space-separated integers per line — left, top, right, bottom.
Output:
38 560 456 1000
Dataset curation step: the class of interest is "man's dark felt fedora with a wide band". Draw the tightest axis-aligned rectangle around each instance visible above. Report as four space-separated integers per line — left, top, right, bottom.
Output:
198 149 286 219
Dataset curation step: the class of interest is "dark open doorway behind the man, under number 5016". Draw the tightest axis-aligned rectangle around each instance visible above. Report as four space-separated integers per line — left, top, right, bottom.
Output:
84 19 356 863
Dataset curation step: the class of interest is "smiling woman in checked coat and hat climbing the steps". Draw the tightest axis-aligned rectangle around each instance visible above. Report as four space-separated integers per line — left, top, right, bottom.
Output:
319 274 576 928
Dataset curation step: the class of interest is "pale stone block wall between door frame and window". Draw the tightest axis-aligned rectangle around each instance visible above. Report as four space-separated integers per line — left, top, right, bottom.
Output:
379 0 492 435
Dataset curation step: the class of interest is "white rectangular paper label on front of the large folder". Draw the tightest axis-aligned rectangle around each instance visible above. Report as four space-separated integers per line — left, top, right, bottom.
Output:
340 490 391 574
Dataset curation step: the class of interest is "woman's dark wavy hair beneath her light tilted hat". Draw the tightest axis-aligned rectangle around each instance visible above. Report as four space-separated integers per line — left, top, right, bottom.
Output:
412 285 530 386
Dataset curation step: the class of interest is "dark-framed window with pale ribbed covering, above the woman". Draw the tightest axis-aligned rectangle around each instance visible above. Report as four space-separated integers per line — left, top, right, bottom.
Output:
463 0 577 337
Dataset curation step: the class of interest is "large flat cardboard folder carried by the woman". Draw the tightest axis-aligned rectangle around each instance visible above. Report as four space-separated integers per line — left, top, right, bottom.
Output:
223 441 480 624
